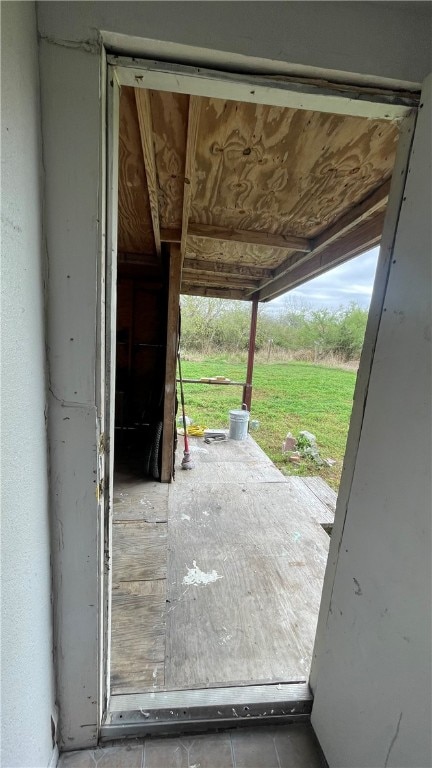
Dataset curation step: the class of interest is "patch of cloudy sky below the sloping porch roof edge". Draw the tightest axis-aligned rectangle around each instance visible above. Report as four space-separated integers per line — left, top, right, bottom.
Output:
266 248 379 311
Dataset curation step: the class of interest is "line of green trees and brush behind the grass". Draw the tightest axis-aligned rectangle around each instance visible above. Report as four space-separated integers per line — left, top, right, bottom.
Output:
181 296 368 361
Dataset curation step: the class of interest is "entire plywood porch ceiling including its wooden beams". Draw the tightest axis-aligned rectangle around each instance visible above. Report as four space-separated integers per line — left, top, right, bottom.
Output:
118 87 399 300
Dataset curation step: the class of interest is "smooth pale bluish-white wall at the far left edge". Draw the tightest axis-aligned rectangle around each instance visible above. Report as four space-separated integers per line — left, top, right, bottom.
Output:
1 3 54 768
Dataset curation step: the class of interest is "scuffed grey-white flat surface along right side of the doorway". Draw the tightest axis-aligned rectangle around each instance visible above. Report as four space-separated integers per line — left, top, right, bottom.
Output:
312 76 432 768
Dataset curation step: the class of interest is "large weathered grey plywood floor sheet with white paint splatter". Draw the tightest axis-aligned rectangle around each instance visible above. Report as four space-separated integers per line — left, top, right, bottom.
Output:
166 480 329 688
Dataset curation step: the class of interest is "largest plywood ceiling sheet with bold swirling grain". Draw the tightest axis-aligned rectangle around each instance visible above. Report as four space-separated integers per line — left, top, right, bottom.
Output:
191 98 398 237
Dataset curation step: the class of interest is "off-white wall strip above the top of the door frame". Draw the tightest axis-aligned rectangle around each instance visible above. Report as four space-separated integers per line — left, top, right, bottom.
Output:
38 1 432 84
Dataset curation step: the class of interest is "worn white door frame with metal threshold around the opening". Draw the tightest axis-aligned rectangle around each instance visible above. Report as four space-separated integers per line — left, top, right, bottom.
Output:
100 55 418 741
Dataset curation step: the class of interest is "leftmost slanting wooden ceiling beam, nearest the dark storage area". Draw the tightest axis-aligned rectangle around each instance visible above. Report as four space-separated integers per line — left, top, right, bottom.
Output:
135 88 161 256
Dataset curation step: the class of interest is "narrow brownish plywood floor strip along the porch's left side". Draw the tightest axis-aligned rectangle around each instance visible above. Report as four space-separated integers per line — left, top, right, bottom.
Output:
111 480 168 694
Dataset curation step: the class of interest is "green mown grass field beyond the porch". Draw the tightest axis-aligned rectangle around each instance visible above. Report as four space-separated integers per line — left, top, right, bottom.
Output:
182 358 356 490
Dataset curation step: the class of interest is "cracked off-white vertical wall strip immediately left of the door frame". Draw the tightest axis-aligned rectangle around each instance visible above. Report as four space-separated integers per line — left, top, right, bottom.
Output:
40 42 103 749
